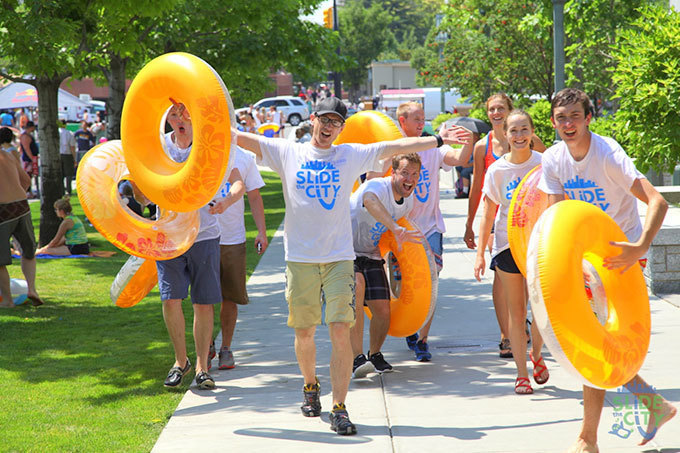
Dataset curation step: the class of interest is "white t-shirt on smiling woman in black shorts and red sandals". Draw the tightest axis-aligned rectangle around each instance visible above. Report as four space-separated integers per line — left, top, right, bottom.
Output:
482 151 541 256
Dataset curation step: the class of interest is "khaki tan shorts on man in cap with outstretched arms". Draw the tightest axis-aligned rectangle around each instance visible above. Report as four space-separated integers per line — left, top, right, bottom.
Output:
286 261 356 329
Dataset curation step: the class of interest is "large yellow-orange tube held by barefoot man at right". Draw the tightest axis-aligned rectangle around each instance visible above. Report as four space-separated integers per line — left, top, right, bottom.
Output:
527 200 651 389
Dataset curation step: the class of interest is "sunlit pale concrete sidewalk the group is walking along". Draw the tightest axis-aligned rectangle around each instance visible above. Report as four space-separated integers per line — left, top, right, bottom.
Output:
153 182 680 453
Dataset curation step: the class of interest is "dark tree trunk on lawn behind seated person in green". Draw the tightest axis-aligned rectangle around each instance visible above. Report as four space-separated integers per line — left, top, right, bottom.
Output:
35 77 64 246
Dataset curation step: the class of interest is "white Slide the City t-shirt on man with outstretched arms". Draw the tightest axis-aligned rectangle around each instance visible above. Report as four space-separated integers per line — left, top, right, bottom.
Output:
260 138 385 263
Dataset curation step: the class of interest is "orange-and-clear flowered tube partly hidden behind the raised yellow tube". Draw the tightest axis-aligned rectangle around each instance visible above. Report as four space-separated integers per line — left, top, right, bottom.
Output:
76 140 199 260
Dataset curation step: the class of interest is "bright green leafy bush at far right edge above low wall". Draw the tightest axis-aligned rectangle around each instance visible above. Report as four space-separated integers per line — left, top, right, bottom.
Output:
613 6 680 172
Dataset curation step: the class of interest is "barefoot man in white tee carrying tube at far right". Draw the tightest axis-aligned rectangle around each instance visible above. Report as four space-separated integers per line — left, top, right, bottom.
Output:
538 88 677 453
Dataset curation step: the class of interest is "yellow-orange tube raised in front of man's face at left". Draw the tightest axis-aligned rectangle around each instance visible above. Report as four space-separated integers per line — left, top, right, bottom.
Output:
121 53 233 212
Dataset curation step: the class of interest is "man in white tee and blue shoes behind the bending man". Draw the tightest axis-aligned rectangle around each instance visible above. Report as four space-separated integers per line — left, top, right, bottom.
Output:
397 102 473 362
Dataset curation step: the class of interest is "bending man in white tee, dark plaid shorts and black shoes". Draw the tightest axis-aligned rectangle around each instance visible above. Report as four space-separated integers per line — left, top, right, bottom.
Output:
349 153 420 378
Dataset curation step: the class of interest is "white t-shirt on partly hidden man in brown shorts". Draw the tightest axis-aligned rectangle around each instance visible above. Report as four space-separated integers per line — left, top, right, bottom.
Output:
217 146 264 245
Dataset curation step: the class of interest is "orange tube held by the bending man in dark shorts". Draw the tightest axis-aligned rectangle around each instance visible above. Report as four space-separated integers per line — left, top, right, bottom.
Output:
369 218 437 337
